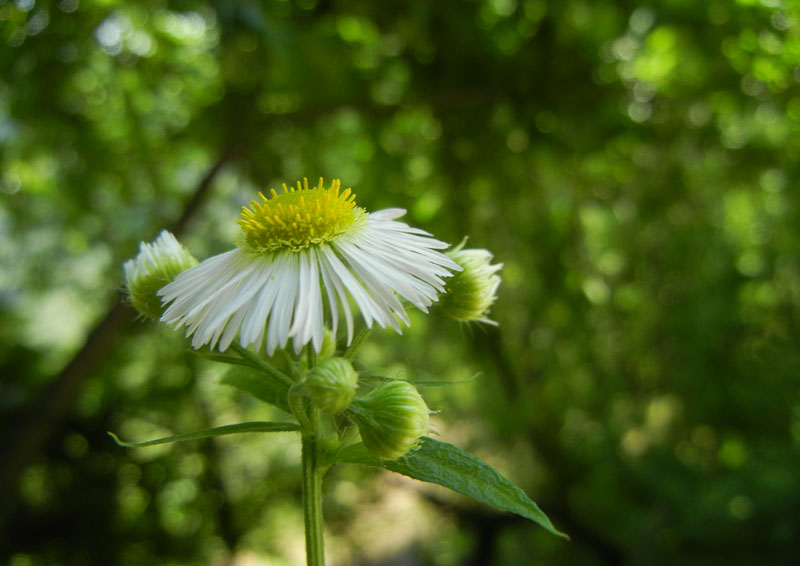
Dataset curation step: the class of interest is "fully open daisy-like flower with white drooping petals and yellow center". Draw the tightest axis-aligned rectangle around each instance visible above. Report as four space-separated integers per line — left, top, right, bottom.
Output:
159 179 461 355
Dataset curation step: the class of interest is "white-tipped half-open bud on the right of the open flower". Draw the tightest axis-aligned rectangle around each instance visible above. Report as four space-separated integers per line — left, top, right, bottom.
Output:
439 240 503 325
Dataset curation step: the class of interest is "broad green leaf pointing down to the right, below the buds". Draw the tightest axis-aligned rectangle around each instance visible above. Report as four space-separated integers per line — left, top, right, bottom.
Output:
336 437 569 538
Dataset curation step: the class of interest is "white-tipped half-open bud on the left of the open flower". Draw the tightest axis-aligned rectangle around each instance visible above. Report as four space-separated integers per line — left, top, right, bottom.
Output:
123 230 197 319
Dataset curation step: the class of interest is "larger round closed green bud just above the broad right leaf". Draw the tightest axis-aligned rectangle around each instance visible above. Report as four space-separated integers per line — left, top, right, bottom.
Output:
350 381 430 460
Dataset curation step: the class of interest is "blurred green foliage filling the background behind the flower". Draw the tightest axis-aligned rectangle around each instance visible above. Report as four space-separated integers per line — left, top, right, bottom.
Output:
0 0 800 566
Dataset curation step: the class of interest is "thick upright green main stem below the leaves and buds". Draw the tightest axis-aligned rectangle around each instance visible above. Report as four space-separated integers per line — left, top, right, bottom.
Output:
303 433 325 566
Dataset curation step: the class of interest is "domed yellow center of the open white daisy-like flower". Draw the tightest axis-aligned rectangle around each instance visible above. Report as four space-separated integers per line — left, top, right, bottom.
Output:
239 179 367 253
